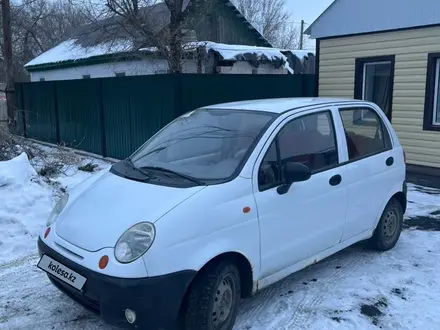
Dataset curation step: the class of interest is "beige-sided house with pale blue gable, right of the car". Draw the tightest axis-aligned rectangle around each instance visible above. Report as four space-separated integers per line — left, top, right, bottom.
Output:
306 0 440 184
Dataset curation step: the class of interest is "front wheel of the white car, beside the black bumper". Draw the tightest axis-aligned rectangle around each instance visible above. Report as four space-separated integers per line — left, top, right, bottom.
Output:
182 262 241 330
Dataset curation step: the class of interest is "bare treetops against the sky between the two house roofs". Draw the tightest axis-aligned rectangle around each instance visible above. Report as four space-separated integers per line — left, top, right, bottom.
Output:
233 0 300 49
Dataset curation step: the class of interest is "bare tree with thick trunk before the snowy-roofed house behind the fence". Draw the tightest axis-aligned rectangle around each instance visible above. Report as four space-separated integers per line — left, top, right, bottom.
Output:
79 0 215 73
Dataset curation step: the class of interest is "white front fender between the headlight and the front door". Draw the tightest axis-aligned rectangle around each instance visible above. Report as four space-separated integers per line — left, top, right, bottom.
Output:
144 178 260 279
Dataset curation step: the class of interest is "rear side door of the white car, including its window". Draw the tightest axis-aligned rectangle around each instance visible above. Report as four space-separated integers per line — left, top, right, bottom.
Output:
339 107 403 241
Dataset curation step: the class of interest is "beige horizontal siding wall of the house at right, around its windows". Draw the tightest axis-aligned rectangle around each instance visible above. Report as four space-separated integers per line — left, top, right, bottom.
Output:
319 27 440 168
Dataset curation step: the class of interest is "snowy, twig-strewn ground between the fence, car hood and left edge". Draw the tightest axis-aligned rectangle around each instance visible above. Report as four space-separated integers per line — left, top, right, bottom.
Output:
0 146 109 266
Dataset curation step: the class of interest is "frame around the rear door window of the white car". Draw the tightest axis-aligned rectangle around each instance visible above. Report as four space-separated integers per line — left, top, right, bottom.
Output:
336 105 394 166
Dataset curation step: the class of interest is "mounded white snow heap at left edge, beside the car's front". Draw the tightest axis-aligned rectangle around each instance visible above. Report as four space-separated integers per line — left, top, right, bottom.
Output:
0 153 53 265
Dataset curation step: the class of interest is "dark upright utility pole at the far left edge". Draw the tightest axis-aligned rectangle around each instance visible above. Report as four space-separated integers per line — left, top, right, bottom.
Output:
0 0 16 128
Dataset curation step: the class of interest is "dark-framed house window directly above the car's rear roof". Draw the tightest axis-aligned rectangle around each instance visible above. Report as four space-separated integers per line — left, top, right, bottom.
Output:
355 56 394 119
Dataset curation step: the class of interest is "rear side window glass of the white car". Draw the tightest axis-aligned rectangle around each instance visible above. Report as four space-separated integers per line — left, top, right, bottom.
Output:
340 108 391 160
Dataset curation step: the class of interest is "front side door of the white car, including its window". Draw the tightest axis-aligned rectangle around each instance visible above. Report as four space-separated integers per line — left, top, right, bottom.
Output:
253 111 346 278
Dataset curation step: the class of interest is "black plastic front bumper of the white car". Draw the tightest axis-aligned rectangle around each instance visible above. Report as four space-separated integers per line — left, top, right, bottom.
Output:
38 238 196 330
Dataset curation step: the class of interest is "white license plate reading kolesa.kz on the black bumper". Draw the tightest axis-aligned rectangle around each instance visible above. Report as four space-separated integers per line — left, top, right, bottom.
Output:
37 255 87 290
